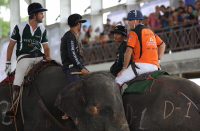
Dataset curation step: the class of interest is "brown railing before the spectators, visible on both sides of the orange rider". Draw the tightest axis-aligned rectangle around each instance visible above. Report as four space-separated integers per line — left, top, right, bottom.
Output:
83 23 200 65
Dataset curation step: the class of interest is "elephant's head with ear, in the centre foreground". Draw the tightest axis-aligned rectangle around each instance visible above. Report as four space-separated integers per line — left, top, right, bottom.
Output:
55 72 129 131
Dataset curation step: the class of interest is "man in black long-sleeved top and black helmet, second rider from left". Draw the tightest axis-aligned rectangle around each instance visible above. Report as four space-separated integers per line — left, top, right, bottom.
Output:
60 14 89 83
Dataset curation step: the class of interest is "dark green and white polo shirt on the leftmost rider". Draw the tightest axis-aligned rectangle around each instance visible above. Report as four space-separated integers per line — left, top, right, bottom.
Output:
11 20 48 57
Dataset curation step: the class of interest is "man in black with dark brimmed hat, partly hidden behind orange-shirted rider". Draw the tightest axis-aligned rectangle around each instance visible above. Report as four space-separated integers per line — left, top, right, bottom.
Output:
110 25 131 77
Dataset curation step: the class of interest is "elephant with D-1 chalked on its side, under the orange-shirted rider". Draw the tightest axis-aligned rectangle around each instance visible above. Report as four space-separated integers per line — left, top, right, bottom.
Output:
123 75 200 131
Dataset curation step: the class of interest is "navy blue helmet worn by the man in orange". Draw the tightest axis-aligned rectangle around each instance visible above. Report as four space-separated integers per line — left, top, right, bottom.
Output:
125 10 144 20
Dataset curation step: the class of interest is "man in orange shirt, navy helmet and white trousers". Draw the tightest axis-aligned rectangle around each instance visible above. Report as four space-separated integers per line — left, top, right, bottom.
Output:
115 10 165 91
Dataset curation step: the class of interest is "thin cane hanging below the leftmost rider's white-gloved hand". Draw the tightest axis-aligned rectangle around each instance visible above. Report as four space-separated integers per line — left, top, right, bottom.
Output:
8 72 18 131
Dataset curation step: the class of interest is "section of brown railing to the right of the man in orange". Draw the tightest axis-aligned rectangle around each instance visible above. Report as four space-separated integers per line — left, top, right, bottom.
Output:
155 23 200 53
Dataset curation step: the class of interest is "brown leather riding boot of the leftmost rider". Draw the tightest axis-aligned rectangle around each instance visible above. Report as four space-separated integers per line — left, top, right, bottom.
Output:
6 85 20 117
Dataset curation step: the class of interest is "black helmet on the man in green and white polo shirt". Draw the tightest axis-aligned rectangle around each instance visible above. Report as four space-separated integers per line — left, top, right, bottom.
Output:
28 3 47 15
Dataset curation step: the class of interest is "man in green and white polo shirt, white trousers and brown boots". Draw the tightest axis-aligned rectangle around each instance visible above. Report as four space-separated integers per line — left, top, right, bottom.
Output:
5 3 51 116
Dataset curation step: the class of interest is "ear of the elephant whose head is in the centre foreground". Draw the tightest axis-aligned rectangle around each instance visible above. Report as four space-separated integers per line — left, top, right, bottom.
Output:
55 80 86 120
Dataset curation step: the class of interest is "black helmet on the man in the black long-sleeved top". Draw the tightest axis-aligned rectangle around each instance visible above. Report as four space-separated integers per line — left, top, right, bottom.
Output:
68 14 86 27
